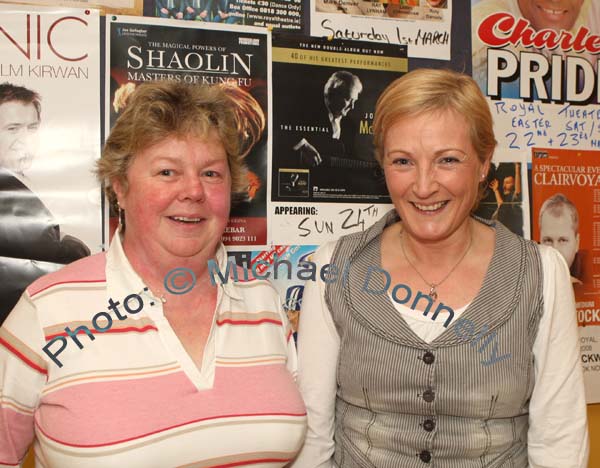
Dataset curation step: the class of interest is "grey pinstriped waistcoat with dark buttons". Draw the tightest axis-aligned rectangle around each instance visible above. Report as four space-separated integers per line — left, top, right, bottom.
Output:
325 210 543 468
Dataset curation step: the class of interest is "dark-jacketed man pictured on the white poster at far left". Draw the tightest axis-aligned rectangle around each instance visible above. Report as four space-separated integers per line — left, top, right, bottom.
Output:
0 82 90 324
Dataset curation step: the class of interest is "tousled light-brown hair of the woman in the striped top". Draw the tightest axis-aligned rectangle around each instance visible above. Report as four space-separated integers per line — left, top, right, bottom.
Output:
96 81 265 207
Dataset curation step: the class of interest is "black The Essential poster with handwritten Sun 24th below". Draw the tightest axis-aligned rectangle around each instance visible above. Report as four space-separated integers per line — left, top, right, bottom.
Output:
269 35 407 245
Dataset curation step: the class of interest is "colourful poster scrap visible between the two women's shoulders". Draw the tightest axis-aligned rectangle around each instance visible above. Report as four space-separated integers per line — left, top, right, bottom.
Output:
229 245 321 339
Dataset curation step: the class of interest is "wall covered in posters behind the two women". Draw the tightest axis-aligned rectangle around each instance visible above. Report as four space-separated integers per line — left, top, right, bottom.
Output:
0 0 600 464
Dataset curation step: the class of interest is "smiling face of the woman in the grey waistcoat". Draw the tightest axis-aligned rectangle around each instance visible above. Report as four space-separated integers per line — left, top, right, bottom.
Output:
383 111 489 242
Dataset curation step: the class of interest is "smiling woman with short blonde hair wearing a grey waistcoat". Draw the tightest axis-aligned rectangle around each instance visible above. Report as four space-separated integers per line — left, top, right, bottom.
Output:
294 69 588 468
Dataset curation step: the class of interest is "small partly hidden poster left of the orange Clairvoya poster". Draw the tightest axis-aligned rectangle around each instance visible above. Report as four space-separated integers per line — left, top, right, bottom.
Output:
475 149 529 238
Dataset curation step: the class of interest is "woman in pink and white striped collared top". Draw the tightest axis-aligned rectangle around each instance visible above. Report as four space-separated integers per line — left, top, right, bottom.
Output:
0 82 306 468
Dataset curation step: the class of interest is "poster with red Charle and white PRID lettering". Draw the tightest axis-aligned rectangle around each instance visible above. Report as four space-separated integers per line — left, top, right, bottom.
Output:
471 0 600 154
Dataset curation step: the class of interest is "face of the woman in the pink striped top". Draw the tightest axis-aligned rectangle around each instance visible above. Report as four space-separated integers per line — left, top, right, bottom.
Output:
114 130 231 261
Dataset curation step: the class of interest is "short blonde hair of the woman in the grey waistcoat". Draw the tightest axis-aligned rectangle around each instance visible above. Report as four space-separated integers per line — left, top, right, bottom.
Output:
373 68 497 164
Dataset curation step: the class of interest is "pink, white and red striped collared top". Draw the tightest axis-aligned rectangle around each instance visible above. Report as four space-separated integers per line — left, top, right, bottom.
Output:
0 236 306 468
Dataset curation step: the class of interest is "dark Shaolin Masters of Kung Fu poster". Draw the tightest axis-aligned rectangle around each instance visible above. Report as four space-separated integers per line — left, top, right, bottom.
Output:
106 16 271 246
